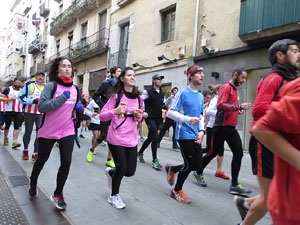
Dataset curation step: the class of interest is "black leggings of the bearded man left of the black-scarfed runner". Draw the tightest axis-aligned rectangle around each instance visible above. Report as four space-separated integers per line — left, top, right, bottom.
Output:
198 126 243 186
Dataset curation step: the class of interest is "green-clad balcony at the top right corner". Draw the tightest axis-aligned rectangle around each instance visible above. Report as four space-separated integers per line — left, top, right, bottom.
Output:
239 0 300 43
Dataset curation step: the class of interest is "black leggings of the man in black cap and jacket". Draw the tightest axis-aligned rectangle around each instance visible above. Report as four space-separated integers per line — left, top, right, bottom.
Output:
139 118 160 162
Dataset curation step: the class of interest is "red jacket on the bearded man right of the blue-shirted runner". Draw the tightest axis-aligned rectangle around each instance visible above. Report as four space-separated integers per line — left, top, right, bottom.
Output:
214 82 240 127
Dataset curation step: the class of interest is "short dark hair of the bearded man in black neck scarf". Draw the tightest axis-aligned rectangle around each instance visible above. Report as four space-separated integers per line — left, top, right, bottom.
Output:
268 39 298 65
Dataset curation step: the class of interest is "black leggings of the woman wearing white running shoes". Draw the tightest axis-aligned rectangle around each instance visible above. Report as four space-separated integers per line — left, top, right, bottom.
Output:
108 143 137 195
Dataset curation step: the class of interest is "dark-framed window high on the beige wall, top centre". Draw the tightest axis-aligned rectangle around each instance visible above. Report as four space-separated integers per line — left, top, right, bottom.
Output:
161 6 176 42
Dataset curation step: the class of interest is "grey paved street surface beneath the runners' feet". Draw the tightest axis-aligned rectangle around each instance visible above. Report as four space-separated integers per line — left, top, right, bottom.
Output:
0 126 272 225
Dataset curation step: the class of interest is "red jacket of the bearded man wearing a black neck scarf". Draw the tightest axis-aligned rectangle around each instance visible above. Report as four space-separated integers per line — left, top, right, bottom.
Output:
249 73 288 133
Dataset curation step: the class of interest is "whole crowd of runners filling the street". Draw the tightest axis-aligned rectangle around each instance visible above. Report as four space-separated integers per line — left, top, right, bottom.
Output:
0 39 300 225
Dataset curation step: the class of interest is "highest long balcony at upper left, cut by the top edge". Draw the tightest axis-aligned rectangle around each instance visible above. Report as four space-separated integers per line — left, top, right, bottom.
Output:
50 0 99 36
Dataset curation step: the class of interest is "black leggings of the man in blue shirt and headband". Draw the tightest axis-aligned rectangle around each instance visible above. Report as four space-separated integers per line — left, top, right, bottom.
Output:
171 140 202 191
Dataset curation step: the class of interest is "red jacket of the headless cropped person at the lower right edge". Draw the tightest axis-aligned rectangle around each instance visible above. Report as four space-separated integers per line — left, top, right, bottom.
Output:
255 78 300 224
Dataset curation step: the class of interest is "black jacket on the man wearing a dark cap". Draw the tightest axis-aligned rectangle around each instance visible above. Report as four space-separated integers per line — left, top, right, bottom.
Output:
144 86 165 119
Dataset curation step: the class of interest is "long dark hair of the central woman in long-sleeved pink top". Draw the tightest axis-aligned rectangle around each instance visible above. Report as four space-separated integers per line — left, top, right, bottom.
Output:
110 67 141 106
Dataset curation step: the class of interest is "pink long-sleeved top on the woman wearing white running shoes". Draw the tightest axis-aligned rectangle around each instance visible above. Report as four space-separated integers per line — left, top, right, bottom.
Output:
100 94 143 147
